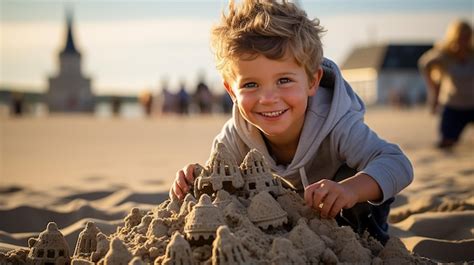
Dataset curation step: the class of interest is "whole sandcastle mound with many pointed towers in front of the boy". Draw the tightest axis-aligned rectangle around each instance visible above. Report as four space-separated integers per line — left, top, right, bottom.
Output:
0 144 434 265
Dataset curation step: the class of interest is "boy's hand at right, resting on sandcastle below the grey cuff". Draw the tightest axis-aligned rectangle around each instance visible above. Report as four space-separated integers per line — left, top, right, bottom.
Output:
304 179 358 218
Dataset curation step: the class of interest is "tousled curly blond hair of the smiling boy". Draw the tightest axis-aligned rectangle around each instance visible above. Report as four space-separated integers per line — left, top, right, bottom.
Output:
211 0 324 81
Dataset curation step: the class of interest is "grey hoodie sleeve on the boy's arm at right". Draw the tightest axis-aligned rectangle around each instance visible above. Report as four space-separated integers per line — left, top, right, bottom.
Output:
332 112 413 204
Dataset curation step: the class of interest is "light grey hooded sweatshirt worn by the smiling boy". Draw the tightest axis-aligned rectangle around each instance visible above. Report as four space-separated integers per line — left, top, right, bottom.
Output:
213 59 413 204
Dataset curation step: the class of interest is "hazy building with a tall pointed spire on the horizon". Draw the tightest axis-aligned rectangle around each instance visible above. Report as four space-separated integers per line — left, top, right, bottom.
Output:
46 9 94 112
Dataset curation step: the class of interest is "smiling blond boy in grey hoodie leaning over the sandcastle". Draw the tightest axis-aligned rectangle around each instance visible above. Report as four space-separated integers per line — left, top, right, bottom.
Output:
170 0 413 243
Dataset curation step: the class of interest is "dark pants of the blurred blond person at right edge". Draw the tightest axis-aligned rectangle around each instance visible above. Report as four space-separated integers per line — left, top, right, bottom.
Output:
440 106 474 142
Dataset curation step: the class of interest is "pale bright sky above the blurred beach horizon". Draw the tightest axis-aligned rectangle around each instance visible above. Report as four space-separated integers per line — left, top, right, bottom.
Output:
0 0 474 95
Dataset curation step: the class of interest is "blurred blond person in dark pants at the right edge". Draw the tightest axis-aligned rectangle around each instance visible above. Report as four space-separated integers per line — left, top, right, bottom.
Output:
419 21 474 148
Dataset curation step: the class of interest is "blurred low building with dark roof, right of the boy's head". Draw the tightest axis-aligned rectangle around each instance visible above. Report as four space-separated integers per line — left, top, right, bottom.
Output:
341 44 432 105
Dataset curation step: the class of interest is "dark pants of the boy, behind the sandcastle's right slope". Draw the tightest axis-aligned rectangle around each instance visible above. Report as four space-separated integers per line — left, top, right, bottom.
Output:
333 165 395 245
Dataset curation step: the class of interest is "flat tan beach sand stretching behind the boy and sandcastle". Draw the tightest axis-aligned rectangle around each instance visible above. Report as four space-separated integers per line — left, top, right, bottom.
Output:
0 106 474 262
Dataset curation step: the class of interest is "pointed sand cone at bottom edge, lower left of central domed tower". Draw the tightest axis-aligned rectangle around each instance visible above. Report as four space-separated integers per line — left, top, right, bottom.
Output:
162 232 195 265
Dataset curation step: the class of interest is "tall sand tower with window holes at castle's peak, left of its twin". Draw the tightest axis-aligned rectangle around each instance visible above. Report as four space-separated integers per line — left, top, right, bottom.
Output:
194 143 244 198
